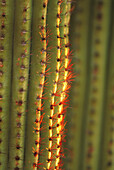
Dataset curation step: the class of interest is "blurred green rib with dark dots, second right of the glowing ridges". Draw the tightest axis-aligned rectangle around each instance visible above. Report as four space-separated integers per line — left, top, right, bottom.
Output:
83 0 111 170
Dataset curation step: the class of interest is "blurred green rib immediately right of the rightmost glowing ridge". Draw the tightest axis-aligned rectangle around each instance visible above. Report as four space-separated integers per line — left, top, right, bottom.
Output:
64 0 92 170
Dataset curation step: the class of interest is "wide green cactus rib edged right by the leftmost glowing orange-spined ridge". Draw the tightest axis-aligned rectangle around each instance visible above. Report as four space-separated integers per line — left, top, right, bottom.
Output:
24 0 47 170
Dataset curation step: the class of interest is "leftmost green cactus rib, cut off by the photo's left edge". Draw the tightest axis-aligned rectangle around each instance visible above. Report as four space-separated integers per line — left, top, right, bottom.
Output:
0 0 14 170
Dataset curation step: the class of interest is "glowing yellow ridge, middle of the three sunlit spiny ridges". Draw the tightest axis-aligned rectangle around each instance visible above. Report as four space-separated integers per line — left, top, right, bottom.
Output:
47 1 61 169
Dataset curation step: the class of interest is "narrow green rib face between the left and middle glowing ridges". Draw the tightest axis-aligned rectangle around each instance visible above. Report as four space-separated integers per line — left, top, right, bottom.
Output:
39 0 58 170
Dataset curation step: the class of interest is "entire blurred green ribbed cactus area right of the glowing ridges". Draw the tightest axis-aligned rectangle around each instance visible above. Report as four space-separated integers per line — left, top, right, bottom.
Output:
63 0 114 170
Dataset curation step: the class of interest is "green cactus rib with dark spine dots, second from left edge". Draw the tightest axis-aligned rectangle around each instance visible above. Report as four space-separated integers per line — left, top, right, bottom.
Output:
8 0 32 170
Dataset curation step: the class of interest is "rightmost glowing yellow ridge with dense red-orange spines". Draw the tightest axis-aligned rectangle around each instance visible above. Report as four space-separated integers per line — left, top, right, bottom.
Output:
56 2 71 167
